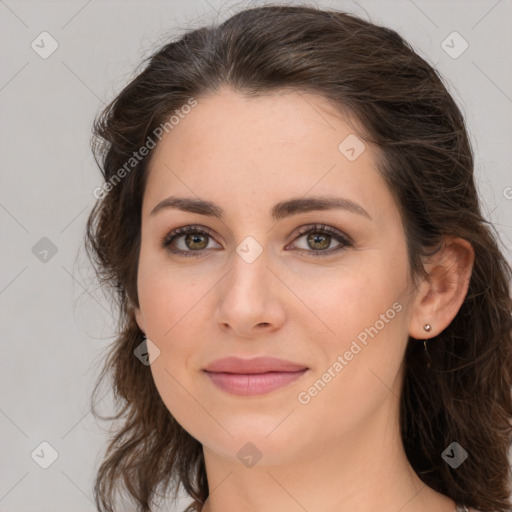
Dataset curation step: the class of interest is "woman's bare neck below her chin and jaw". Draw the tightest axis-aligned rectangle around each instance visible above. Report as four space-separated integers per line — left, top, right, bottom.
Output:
197 392 456 512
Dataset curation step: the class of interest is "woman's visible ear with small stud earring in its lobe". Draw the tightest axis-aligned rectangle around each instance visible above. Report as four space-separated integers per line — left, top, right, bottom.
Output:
409 236 475 339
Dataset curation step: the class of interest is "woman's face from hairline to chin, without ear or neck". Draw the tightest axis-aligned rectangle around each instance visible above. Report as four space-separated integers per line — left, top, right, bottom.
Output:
136 89 420 464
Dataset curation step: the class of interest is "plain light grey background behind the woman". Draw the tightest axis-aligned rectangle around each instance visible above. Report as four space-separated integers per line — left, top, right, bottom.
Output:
0 0 512 512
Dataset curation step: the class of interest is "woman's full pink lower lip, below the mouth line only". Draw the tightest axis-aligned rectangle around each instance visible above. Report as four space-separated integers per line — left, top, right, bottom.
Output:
206 368 308 396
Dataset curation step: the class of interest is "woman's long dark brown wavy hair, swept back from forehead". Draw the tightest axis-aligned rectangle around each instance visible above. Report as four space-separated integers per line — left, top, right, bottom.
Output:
85 5 512 512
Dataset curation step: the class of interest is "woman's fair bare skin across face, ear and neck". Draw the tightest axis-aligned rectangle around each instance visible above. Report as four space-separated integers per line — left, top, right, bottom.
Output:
135 88 474 512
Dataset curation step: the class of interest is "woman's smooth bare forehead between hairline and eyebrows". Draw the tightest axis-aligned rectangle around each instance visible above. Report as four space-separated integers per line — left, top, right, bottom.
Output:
144 89 396 224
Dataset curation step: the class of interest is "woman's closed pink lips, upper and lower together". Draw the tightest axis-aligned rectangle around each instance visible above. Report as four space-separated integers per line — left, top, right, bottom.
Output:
204 357 308 396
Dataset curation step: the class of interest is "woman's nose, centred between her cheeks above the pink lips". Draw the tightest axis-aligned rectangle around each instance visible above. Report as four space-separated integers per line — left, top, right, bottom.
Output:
215 246 286 338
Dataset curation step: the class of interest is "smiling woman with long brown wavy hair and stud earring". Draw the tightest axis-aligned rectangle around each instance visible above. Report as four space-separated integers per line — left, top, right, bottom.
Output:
86 6 512 512
